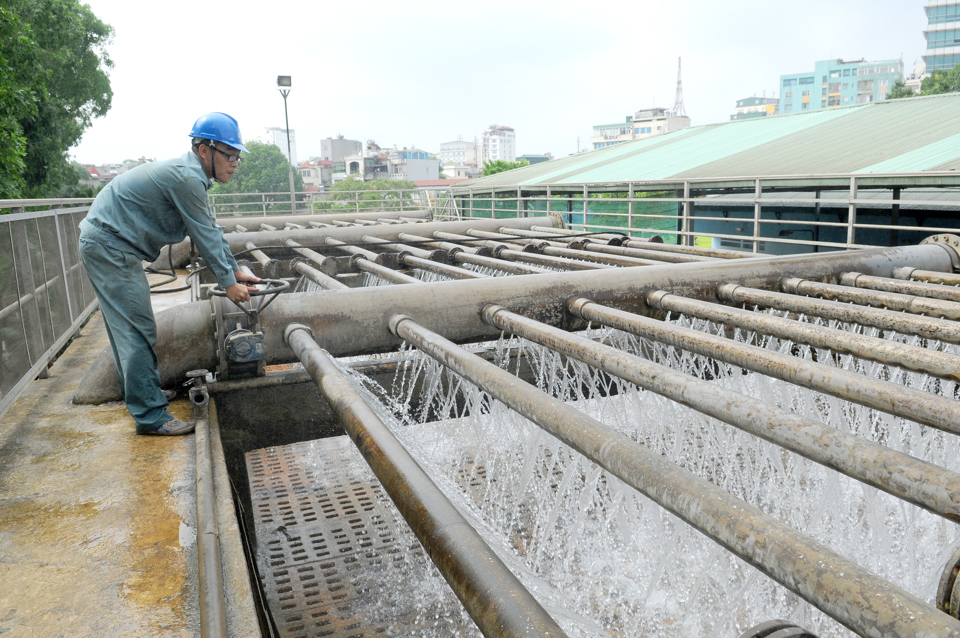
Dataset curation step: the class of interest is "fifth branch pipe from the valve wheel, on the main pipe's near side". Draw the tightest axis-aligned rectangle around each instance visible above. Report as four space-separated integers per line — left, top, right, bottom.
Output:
647 291 960 381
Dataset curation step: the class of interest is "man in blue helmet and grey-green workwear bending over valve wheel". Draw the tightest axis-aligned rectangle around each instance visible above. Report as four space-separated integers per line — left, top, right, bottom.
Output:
80 113 260 435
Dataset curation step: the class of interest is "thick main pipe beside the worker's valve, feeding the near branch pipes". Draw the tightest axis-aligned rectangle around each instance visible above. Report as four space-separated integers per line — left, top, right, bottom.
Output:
74 238 956 403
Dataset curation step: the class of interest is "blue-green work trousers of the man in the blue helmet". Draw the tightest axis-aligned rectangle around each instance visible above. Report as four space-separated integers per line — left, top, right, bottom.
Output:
80 225 173 434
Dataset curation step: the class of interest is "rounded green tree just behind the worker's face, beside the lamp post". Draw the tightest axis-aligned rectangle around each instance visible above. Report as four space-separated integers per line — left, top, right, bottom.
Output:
210 141 303 212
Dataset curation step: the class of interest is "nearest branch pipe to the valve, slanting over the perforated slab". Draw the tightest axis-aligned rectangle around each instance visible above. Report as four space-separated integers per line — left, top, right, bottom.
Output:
284 324 566 638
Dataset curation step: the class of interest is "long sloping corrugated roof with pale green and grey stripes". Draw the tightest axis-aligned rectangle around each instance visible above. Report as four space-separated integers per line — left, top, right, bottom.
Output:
463 93 960 188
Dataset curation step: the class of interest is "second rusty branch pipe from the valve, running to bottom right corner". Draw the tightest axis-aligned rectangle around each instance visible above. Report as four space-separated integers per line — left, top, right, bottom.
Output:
391 316 960 638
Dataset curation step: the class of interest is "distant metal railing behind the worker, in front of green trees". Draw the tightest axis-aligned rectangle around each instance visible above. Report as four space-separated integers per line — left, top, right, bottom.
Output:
209 188 456 217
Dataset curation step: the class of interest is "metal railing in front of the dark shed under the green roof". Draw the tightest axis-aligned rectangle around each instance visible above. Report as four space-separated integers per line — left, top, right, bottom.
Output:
454 174 960 254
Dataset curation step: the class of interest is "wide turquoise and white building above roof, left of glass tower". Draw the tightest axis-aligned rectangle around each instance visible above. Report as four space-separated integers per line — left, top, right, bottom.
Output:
780 60 903 114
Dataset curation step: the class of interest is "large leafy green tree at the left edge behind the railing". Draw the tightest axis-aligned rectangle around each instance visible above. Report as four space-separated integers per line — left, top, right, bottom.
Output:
0 0 113 197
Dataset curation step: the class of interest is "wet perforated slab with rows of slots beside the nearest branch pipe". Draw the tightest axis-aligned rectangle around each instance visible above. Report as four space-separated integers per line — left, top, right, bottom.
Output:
246 436 480 638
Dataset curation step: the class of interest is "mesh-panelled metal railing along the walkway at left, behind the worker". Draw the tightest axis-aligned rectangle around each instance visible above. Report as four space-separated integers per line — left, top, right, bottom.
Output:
0 199 97 416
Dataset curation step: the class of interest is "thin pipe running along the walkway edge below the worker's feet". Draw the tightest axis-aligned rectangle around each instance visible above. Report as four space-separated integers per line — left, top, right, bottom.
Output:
191 394 227 638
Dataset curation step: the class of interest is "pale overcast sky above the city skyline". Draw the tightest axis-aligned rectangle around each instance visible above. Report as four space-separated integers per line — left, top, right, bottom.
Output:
70 0 926 164
